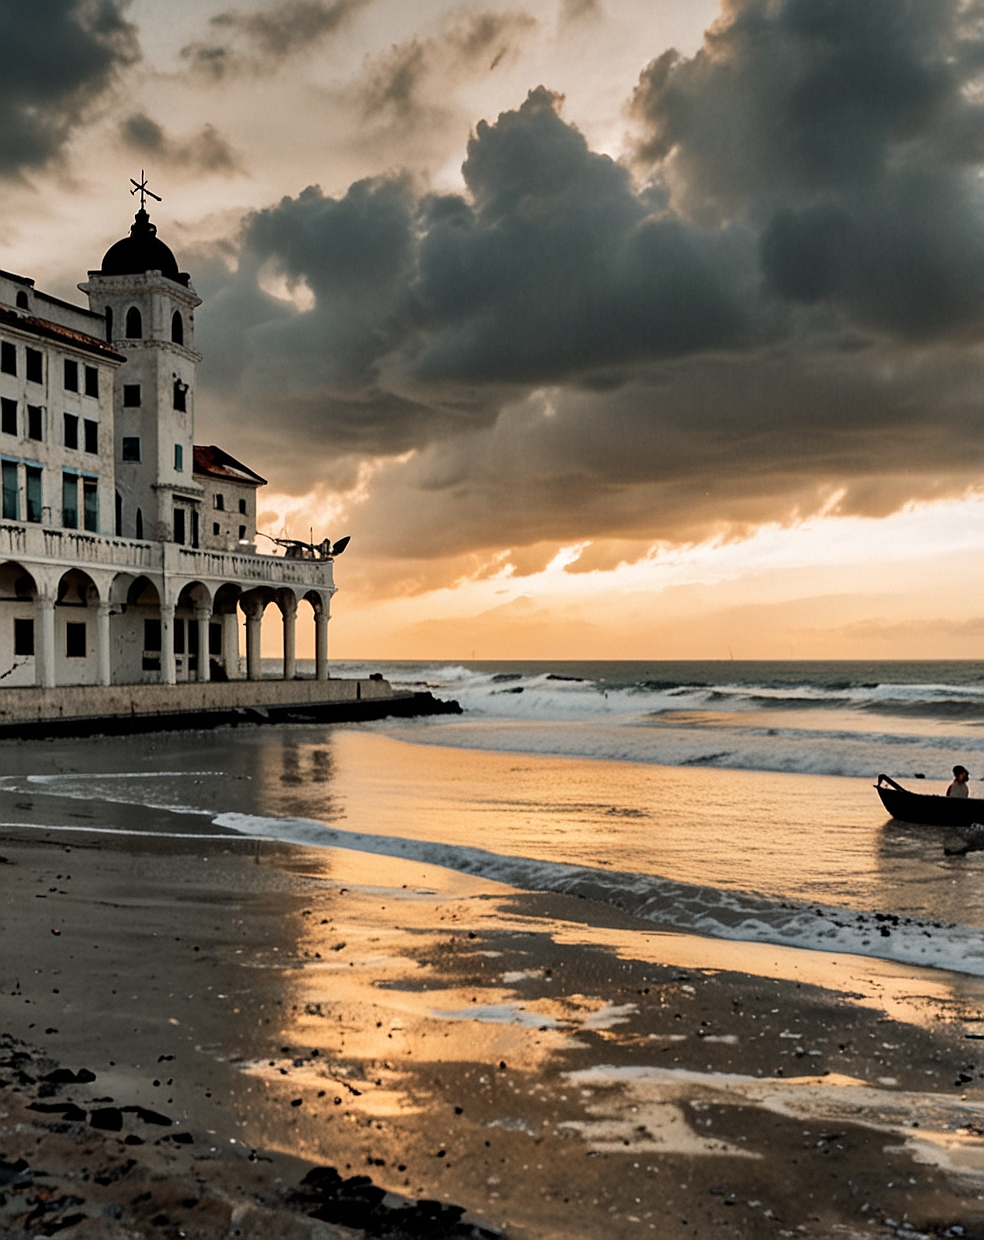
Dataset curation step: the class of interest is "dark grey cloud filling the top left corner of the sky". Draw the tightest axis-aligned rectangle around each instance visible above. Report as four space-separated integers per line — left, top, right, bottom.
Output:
0 0 139 177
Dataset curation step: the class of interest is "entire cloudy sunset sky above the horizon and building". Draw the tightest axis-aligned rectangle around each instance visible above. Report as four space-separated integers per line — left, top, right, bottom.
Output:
0 0 984 660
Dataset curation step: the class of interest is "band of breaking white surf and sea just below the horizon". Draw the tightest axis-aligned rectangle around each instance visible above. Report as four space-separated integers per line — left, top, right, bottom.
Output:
324 662 984 780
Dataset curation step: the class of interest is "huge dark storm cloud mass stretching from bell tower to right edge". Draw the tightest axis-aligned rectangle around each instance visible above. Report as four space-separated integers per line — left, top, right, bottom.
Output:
193 0 984 554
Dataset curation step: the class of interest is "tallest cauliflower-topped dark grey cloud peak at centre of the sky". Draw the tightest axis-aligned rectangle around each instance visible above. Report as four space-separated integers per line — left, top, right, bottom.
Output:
413 89 756 384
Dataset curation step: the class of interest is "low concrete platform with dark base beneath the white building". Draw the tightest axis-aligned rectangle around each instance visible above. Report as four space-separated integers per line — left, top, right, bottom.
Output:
0 680 461 739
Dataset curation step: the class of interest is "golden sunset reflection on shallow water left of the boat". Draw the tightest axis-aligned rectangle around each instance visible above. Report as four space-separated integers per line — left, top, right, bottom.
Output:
239 729 984 925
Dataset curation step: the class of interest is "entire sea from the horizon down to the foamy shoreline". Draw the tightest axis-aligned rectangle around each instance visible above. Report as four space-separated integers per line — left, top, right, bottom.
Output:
0 662 984 976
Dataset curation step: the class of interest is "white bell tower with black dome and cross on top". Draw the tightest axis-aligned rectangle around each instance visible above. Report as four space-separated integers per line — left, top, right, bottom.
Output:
79 180 203 546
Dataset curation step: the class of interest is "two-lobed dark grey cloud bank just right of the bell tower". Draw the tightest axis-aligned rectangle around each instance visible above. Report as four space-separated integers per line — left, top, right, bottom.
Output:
193 89 755 453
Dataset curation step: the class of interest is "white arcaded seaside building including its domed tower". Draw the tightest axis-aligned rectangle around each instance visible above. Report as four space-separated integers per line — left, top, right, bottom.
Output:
0 207 335 688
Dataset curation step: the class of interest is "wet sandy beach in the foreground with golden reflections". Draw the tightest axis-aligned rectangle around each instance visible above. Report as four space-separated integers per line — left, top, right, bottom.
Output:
0 807 984 1240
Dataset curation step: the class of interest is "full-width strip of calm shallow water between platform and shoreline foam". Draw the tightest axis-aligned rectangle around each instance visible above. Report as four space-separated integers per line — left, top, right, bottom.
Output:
0 727 984 926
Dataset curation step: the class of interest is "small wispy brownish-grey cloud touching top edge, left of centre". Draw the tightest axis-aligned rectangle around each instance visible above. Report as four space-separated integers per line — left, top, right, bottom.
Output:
181 0 369 81
